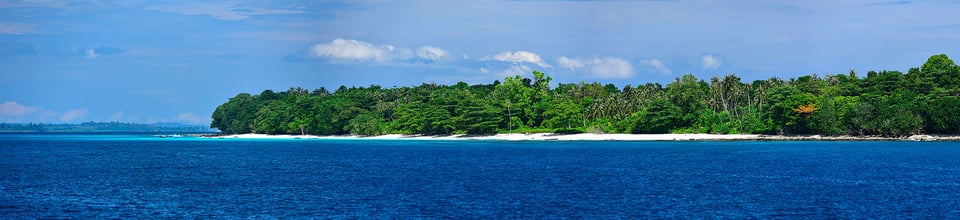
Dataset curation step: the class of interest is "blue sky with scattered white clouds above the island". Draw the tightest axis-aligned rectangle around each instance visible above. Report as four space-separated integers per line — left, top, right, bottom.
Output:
0 0 960 124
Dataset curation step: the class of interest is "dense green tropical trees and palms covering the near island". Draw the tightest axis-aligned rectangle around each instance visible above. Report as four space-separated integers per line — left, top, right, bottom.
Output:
210 54 960 136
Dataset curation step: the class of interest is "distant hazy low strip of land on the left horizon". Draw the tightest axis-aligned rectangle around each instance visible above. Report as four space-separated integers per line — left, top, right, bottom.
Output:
0 122 215 133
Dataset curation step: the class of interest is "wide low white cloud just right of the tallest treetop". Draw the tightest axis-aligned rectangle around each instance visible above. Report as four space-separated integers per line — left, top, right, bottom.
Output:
557 56 634 78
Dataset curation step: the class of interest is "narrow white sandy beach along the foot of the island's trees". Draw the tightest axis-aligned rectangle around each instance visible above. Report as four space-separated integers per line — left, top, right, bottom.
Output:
204 133 960 141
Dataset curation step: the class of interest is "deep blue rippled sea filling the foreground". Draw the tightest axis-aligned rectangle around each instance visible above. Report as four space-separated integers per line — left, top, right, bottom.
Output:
0 135 960 219
